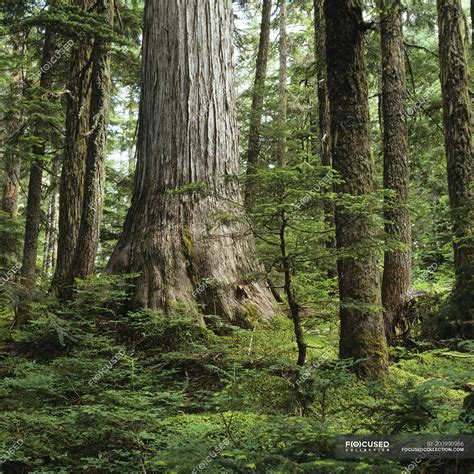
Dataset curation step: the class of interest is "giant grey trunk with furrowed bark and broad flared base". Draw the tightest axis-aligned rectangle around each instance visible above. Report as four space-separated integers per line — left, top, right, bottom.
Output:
108 0 274 325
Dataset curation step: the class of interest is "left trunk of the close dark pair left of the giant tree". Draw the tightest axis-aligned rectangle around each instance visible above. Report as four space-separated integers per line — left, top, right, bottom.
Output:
53 0 94 296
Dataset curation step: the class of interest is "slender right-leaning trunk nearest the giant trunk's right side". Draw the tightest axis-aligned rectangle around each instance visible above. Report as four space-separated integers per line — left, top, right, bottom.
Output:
245 0 272 209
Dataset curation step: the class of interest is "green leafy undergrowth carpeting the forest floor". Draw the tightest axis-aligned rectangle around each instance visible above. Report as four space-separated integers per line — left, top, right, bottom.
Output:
0 278 473 473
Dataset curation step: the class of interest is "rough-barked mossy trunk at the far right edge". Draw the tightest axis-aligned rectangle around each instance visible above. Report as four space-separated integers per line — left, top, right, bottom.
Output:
438 0 474 337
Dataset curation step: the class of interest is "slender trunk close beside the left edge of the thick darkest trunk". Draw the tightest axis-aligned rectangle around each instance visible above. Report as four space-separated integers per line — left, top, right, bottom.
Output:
314 0 337 278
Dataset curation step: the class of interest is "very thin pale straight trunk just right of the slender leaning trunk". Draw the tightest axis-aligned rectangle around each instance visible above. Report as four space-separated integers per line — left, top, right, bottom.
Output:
277 0 288 166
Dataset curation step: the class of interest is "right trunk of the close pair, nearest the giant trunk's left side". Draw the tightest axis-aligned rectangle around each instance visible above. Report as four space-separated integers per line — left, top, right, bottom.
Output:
67 0 114 287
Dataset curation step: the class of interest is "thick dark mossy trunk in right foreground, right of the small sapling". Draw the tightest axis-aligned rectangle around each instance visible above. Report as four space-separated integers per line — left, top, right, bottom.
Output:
325 0 388 379
